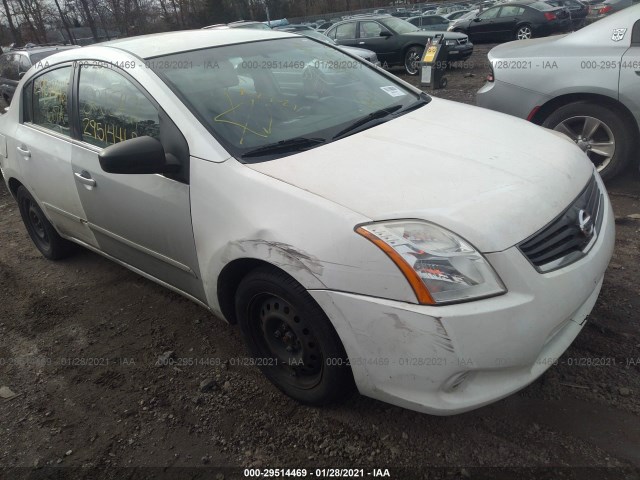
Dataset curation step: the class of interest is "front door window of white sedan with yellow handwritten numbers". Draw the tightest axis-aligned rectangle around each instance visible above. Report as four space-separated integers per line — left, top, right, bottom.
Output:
78 65 160 147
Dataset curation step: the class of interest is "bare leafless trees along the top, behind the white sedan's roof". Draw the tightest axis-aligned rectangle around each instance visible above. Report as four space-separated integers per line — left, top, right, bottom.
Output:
0 0 408 46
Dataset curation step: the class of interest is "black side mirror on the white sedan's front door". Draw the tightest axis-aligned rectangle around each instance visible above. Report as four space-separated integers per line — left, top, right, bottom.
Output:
98 136 180 174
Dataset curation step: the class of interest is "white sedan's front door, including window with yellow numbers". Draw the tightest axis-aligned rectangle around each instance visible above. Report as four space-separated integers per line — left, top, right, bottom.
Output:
72 65 205 300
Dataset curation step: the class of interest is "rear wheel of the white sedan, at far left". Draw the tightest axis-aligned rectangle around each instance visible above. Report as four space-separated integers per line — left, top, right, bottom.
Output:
16 186 76 260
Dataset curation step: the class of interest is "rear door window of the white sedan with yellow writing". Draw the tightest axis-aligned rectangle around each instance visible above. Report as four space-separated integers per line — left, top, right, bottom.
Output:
31 67 71 135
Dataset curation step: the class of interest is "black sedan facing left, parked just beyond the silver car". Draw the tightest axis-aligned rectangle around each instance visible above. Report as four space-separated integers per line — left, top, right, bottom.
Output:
452 0 571 42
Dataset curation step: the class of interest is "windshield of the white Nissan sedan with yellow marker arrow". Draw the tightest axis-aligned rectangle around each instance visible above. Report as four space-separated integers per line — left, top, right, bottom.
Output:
153 37 428 162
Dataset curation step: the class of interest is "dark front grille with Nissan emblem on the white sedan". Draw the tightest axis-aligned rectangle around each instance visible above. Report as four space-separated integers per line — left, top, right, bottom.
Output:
518 176 604 273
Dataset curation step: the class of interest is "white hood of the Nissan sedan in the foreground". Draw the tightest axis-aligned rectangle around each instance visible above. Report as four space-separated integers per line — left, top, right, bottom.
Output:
247 98 593 253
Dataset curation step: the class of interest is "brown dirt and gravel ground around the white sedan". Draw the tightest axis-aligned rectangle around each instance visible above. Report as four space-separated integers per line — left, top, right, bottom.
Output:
0 45 640 480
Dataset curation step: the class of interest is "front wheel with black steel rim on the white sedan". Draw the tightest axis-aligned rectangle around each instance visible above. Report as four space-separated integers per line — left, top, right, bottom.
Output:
236 267 354 405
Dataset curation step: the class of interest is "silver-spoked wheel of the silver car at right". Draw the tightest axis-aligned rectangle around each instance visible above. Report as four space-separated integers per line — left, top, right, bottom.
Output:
542 101 635 180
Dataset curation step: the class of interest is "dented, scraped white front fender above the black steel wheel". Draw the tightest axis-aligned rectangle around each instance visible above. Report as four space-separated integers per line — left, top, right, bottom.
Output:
191 159 416 315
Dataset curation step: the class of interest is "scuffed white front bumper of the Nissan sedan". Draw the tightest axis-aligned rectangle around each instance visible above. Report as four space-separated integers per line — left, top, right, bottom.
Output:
310 178 615 415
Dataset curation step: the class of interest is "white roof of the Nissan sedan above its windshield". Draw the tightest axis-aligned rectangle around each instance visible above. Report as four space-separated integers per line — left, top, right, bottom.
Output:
96 28 296 58
